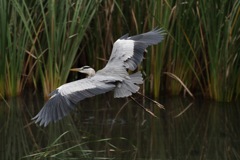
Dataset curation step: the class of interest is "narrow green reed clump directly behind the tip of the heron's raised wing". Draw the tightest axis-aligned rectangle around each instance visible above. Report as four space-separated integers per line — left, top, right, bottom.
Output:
144 0 172 98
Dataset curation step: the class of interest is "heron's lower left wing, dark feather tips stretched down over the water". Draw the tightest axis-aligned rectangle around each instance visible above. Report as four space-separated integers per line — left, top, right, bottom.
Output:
32 75 115 127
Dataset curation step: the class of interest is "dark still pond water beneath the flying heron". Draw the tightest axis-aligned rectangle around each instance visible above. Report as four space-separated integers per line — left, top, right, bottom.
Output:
0 94 240 160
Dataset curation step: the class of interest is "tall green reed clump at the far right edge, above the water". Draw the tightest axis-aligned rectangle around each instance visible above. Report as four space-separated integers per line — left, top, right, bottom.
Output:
198 0 240 101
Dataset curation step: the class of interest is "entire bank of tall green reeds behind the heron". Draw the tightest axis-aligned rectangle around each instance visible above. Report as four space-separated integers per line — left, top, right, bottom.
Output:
0 0 240 101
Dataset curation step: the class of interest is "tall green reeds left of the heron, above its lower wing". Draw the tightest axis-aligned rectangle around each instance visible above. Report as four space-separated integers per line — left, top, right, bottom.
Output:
0 0 100 96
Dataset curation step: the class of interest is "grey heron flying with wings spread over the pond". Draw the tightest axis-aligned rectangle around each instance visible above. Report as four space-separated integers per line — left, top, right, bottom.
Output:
32 29 164 127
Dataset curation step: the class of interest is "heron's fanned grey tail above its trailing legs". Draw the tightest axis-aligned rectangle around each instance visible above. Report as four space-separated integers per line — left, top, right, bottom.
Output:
114 71 143 98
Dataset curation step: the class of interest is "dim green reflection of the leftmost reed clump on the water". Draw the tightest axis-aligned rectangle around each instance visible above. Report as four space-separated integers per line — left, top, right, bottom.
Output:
0 98 31 159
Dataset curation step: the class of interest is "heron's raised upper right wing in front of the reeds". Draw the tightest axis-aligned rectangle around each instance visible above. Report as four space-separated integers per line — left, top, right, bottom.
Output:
106 29 164 71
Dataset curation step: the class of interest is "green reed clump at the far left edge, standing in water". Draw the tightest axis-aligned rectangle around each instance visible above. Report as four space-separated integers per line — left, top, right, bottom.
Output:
0 0 32 96
